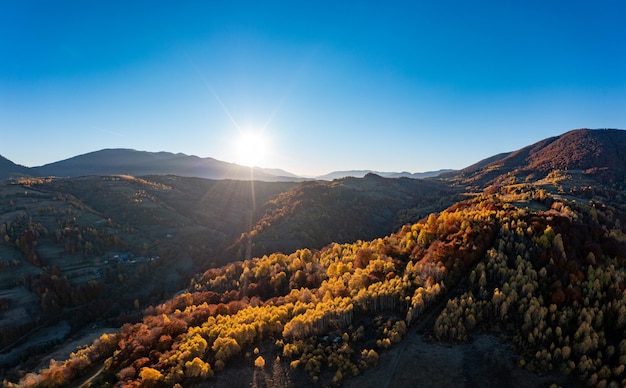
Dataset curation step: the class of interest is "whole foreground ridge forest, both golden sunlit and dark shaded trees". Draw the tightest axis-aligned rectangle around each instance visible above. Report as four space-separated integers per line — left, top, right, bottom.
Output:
9 185 626 386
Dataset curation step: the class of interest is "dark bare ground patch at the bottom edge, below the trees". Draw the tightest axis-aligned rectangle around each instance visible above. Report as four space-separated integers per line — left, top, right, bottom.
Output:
344 332 582 388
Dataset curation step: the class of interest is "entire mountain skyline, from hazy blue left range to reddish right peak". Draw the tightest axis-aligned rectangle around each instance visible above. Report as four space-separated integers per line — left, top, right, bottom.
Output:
0 129 626 184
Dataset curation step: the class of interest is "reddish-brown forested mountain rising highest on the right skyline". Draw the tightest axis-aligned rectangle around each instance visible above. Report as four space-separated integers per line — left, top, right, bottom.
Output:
442 129 626 187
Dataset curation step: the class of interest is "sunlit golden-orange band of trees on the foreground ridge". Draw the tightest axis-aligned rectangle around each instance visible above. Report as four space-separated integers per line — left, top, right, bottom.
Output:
12 186 495 386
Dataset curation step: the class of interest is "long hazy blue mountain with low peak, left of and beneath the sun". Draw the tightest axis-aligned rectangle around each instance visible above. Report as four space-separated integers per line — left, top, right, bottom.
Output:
32 149 296 181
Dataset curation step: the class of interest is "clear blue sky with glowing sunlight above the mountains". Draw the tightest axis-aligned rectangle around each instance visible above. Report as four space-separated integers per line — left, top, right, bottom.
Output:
0 0 626 175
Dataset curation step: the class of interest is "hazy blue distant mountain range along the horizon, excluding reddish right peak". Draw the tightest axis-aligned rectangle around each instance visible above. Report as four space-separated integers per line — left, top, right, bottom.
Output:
0 149 451 182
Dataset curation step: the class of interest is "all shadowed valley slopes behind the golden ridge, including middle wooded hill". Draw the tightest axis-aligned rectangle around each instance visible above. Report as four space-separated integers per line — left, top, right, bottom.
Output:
0 175 455 376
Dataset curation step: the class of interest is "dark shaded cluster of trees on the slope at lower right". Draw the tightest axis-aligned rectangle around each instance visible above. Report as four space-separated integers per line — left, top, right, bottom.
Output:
434 186 626 386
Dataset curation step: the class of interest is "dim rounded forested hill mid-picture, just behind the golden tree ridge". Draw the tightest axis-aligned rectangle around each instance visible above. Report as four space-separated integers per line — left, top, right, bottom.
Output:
225 173 460 259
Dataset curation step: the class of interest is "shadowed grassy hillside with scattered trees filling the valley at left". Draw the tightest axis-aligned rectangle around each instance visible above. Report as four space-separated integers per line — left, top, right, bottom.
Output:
0 176 297 368
